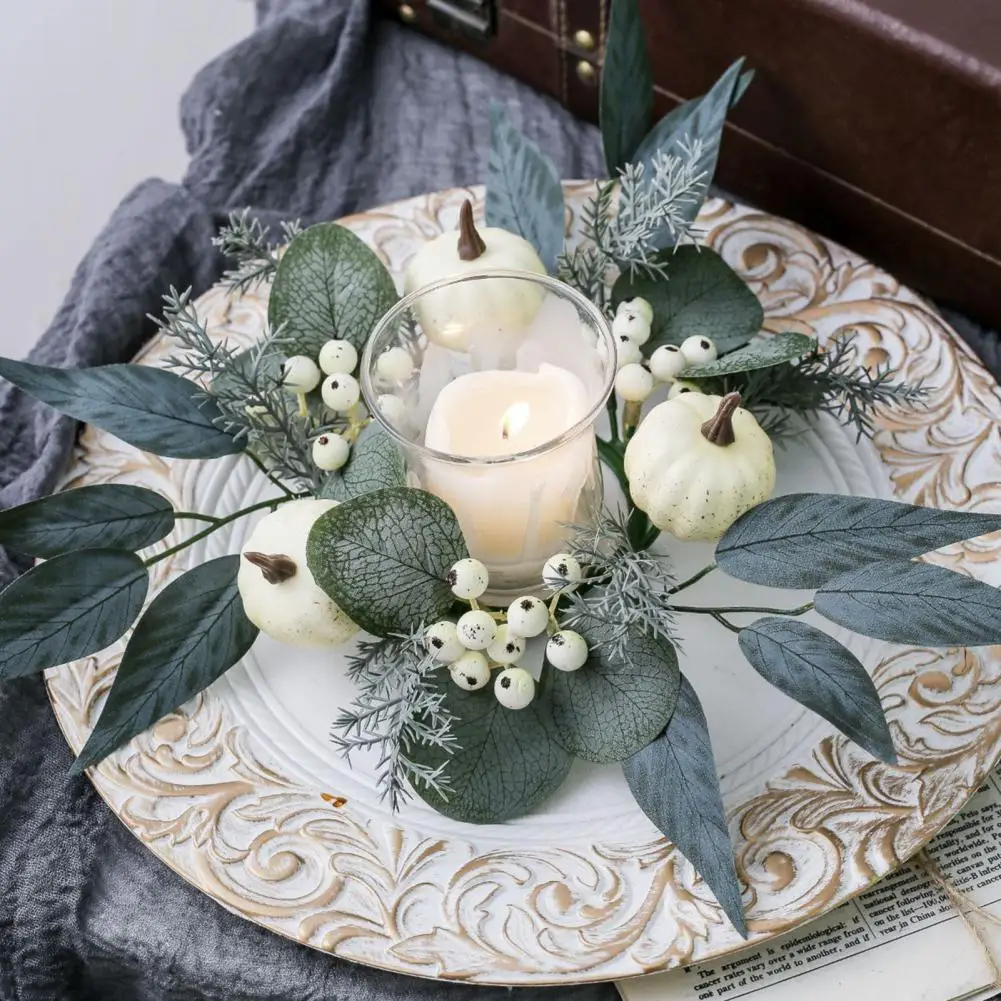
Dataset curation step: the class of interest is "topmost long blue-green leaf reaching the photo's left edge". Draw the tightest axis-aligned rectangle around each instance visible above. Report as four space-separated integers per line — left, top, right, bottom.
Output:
0 358 242 458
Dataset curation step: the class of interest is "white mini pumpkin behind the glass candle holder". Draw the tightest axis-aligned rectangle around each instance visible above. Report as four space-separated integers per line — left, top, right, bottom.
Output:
403 199 547 351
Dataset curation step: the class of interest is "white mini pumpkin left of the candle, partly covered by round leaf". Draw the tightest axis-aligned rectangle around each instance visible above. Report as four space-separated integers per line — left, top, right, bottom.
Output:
236 498 358 648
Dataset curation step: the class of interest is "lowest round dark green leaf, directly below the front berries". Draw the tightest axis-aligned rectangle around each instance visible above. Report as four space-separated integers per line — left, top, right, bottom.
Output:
410 671 574 824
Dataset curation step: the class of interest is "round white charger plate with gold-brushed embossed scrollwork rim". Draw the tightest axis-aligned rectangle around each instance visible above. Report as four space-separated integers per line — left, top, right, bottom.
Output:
47 183 1001 984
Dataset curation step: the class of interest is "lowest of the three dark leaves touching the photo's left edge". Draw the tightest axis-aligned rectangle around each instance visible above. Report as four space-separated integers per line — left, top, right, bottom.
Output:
0 550 149 679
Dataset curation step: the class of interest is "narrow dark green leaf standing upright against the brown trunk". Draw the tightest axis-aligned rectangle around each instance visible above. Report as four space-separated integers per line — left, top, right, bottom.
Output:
600 0 654 177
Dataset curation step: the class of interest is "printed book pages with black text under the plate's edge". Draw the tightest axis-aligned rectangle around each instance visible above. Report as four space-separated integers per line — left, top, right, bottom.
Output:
618 769 1001 1001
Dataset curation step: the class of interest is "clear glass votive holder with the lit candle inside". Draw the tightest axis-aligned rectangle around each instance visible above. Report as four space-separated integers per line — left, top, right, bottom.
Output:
360 270 616 599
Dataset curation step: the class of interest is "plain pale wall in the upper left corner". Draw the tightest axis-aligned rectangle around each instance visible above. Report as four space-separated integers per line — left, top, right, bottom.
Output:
0 0 253 357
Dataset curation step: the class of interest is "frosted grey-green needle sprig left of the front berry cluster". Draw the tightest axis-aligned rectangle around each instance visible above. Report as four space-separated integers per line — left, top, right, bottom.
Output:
330 629 458 811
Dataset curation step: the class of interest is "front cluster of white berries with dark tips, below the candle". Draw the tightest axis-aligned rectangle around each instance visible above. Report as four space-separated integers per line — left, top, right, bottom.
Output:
424 553 588 709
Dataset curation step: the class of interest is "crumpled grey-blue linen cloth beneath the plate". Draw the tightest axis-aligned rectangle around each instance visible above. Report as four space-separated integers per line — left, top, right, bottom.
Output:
0 0 999 1001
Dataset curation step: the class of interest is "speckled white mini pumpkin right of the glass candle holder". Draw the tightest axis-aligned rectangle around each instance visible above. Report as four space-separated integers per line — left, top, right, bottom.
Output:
626 392 775 540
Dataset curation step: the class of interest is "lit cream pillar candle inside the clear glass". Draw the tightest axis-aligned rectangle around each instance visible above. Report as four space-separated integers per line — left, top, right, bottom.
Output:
423 362 595 587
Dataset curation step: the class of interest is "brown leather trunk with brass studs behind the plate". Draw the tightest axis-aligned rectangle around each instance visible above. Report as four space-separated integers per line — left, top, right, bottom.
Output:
380 0 1001 326
